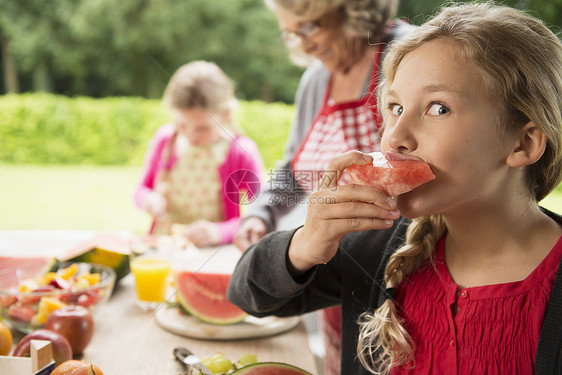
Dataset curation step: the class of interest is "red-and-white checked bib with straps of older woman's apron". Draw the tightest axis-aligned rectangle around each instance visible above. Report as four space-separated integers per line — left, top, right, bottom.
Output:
291 47 382 193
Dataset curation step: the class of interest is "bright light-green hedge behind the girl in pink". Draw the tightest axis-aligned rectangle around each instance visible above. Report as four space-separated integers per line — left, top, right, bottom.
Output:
0 94 293 168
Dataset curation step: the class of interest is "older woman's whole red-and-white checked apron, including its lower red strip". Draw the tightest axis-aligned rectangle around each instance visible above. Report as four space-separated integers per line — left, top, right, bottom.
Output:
291 47 382 375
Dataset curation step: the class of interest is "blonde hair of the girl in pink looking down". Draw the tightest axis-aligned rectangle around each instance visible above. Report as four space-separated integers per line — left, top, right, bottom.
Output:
163 61 236 114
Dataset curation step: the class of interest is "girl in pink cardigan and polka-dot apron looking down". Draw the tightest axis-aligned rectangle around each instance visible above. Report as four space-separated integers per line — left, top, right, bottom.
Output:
134 61 263 246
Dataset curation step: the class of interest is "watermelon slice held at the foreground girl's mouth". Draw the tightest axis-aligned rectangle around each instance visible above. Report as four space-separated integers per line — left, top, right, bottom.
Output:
346 152 435 196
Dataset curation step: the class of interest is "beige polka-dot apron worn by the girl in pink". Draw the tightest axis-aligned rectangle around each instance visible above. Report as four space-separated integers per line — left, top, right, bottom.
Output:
153 135 230 234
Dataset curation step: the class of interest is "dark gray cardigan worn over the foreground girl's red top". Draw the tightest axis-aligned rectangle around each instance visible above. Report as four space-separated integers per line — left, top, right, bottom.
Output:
228 210 562 375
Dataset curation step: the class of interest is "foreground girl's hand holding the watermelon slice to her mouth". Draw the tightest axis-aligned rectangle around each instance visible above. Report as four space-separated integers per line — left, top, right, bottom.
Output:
289 151 400 276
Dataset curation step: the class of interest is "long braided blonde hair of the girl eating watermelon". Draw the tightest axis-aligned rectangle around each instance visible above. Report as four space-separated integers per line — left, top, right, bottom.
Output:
358 3 562 373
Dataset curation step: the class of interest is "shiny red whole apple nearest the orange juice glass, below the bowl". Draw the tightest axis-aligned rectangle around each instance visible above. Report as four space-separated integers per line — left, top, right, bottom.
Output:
45 306 94 355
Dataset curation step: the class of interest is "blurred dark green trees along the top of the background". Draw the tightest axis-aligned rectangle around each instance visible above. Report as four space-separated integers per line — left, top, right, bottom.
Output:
0 0 562 102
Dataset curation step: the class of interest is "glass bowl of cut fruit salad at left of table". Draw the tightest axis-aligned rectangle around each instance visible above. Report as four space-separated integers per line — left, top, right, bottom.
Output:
0 263 116 333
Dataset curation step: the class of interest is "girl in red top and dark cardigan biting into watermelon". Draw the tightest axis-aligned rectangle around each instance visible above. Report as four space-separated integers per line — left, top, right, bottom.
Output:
228 3 562 375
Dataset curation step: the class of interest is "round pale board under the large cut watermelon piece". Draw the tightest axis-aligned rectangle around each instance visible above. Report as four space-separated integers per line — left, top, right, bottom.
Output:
156 307 301 340
